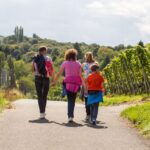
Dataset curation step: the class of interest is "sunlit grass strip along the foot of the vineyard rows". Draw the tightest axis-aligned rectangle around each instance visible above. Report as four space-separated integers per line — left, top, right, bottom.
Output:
102 95 150 106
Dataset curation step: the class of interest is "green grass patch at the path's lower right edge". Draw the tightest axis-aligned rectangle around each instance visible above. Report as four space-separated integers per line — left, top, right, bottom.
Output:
121 102 150 138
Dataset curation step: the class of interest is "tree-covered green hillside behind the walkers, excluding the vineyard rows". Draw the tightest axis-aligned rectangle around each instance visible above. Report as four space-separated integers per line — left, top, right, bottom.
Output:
0 27 150 99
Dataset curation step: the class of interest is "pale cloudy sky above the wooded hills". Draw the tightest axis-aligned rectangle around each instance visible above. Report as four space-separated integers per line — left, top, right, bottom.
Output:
0 0 150 46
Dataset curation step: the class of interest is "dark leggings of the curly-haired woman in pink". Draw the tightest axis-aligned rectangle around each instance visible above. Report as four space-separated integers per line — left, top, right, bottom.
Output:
67 91 77 118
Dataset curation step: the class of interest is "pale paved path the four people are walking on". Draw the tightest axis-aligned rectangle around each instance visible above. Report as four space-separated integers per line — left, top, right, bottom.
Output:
0 100 150 150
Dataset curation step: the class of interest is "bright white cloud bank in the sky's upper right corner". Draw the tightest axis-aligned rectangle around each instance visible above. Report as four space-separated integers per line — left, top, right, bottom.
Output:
86 0 150 37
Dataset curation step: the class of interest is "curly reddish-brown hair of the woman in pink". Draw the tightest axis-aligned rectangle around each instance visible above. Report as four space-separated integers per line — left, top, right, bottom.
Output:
65 48 78 61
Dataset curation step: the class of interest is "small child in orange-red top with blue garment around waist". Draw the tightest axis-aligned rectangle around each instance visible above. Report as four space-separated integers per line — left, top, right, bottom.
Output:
87 63 104 125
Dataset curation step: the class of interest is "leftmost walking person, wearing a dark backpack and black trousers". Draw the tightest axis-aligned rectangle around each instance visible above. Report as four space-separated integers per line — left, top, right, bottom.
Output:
32 46 54 119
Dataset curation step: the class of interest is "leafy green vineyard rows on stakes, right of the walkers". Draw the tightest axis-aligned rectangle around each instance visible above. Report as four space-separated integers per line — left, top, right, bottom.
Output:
103 45 150 94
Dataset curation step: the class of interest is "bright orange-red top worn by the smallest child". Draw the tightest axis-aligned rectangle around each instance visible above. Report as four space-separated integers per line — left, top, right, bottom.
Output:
87 72 104 91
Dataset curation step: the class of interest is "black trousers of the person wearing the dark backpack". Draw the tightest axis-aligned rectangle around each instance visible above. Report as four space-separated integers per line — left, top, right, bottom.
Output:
35 76 50 113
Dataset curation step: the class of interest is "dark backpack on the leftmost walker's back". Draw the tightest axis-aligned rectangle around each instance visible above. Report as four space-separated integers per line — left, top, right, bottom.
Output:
34 55 47 77
